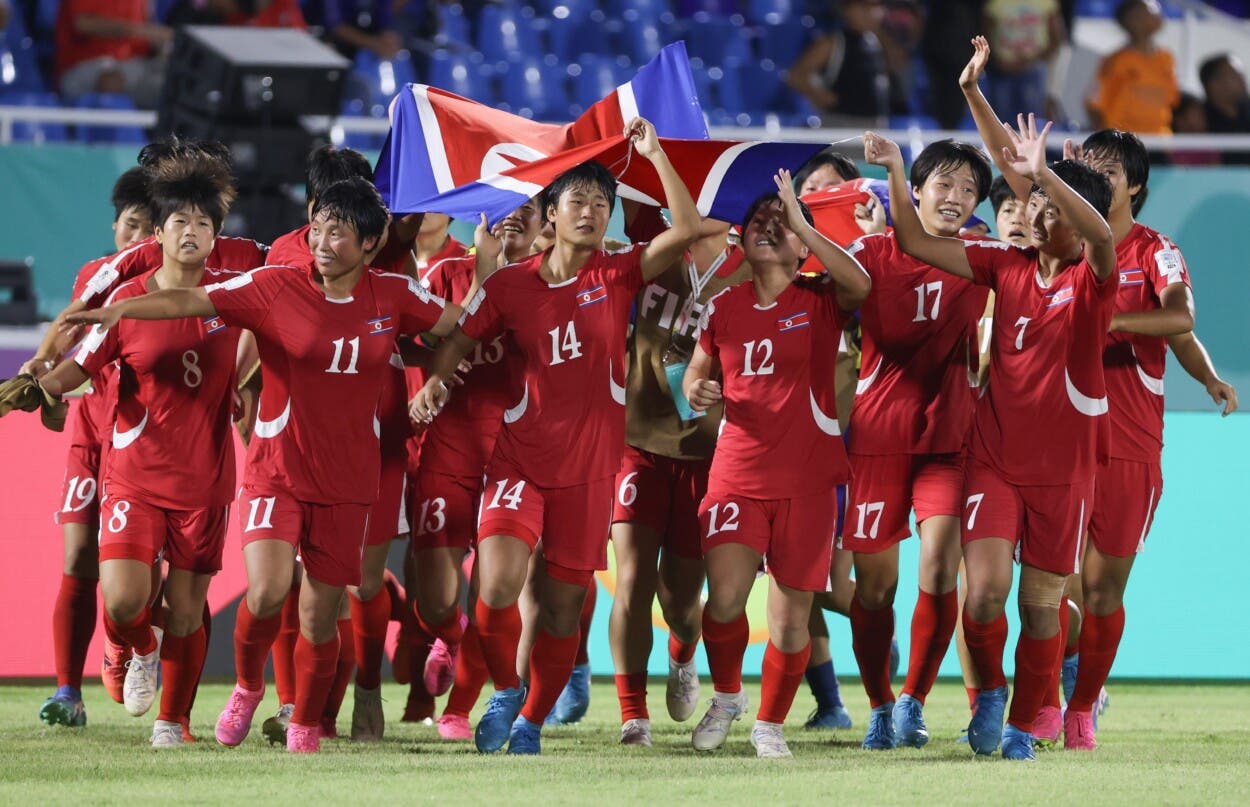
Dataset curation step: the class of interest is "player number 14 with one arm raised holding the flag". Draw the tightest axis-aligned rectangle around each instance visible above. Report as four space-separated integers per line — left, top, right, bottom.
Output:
414 119 699 753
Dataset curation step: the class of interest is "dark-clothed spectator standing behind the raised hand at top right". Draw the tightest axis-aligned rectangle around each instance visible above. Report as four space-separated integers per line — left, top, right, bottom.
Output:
920 0 984 129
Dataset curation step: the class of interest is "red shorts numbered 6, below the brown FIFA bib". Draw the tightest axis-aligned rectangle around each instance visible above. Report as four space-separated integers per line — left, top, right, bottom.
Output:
613 446 711 560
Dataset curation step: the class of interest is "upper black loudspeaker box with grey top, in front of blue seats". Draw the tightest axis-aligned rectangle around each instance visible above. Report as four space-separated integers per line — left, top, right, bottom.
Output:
158 25 351 123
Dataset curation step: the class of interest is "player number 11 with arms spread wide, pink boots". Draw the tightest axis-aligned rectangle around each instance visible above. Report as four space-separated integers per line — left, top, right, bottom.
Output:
71 179 460 752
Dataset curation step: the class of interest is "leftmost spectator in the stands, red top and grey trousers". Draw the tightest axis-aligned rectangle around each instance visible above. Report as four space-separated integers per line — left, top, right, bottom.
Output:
56 0 173 107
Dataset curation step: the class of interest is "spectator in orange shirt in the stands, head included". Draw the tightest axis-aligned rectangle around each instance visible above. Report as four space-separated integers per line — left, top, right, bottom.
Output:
1088 0 1180 135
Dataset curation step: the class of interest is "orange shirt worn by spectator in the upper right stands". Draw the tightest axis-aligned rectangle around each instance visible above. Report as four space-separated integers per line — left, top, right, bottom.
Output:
1090 47 1180 135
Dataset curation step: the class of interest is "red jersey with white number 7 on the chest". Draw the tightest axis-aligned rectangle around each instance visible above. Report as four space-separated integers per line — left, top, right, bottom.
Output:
965 240 1119 485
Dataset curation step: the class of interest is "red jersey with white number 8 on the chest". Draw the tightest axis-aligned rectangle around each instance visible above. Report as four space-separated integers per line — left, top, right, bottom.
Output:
75 270 239 510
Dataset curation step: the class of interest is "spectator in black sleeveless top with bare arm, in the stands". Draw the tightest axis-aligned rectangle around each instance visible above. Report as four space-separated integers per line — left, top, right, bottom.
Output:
786 0 906 124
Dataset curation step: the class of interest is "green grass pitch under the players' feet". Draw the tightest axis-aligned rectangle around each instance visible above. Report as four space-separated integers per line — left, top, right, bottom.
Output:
0 681 1250 806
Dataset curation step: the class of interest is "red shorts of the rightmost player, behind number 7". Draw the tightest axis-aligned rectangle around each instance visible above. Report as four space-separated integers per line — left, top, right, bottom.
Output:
1090 458 1164 557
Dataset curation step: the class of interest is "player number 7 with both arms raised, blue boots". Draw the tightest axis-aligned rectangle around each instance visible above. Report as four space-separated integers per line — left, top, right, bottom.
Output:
864 116 1119 760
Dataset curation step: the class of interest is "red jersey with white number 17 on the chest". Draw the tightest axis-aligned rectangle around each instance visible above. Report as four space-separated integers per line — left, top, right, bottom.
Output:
848 231 989 455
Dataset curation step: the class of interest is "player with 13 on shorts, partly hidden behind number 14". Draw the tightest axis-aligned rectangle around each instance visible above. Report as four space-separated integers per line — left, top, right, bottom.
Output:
411 199 543 740
